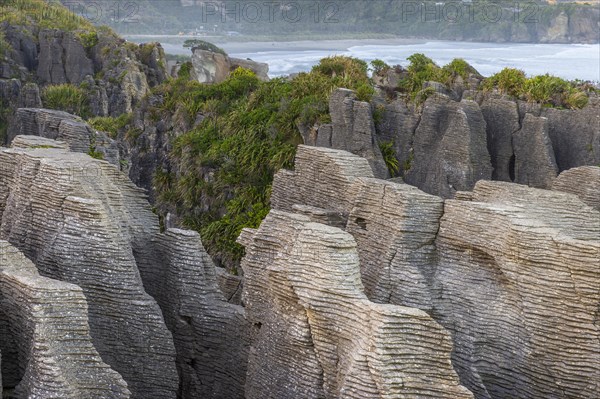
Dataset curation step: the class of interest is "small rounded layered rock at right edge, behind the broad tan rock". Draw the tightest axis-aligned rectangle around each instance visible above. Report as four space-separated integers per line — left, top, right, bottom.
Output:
552 166 600 211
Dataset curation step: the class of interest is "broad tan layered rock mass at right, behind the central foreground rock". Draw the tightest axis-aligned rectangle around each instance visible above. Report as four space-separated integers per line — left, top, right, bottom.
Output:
274 146 600 399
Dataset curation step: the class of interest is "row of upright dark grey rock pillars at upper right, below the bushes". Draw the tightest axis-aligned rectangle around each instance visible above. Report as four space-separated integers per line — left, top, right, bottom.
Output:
358 85 600 198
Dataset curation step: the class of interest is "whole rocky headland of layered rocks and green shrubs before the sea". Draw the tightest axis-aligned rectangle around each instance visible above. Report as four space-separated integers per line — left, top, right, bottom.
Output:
0 0 600 399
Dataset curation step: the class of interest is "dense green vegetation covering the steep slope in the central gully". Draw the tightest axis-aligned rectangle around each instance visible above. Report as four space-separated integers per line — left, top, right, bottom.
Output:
154 57 369 266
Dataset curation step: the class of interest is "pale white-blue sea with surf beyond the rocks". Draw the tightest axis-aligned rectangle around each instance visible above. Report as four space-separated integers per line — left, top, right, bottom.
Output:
152 39 600 82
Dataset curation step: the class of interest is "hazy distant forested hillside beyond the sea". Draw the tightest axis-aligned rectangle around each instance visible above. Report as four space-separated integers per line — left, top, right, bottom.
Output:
63 0 600 43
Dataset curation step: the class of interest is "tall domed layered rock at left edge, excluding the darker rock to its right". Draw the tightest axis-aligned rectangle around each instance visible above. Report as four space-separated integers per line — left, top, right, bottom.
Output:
0 148 178 398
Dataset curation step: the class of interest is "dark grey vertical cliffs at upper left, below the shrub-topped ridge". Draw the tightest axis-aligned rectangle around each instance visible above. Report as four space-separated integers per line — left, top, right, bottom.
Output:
0 23 168 116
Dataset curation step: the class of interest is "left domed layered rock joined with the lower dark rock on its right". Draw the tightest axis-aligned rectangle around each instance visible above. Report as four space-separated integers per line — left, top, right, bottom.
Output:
0 136 248 399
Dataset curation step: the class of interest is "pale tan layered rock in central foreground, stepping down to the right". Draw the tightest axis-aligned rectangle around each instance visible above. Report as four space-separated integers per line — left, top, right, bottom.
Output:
240 211 473 399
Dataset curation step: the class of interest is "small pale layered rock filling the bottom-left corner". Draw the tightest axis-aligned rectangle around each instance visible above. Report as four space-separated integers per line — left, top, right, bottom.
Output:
0 241 130 399
